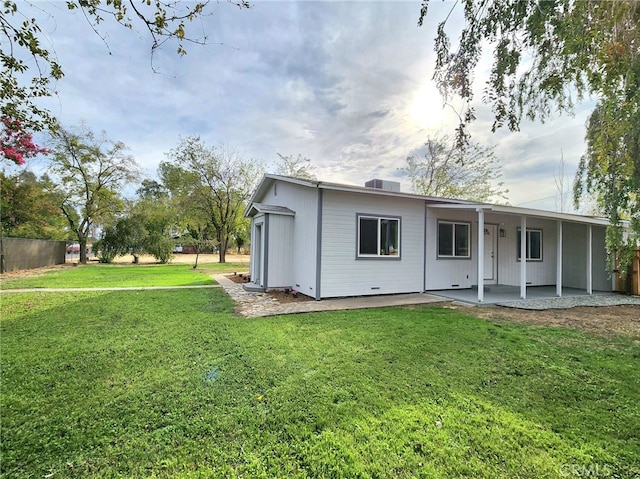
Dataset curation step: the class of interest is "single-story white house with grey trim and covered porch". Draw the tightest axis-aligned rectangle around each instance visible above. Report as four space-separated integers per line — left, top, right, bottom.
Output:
245 174 613 302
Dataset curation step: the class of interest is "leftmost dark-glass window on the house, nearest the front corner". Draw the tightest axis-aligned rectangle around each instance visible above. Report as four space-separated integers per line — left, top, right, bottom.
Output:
358 216 400 257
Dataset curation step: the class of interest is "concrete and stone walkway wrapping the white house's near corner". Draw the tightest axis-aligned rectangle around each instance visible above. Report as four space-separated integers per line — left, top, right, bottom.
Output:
213 274 451 318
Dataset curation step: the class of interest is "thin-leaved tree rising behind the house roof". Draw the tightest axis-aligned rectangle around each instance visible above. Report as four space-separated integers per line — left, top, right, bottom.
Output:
401 135 508 201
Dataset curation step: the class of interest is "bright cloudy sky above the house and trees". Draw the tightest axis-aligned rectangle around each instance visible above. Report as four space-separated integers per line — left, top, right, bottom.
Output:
20 0 592 210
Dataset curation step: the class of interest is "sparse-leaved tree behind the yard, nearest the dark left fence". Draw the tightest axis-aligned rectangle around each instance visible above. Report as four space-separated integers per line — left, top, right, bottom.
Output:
50 126 139 263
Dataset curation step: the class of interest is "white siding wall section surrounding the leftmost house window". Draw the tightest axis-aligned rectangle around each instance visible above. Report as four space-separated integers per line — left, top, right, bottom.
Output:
321 190 424 298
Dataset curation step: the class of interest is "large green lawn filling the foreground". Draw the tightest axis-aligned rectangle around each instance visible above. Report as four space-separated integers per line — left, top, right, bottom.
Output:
0 266 640 478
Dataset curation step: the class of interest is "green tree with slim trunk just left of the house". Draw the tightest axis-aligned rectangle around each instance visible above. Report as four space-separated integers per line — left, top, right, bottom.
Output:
160 136 261 263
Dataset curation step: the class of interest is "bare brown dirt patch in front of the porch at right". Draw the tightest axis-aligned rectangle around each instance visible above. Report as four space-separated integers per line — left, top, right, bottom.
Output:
456 305 640 341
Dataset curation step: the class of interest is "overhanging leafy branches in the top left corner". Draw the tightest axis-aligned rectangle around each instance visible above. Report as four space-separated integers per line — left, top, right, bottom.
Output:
0 0 250 130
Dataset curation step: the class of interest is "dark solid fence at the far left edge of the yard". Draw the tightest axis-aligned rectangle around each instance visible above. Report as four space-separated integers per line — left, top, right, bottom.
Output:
0 238 67 273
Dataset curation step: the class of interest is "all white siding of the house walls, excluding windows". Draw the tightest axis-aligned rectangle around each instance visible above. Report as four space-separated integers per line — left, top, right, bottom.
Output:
252 176 611 298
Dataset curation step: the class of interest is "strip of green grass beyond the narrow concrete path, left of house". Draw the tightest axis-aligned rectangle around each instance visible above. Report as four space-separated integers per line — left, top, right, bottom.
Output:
2 263 248 289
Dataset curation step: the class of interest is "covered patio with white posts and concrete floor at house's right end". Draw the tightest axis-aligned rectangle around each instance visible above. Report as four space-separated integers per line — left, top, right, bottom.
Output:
428 204 613 304
